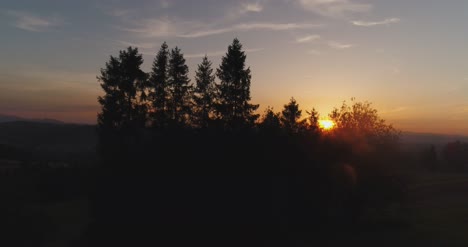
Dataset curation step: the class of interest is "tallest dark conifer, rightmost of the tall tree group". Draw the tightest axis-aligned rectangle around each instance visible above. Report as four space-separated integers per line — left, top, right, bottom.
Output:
216 38 259 129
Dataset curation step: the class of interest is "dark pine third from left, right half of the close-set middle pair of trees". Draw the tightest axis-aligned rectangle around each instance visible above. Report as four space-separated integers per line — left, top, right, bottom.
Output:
167 47 192 126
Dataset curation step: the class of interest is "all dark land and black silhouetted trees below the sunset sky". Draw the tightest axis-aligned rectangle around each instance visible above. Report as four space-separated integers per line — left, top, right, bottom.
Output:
0 39 468 246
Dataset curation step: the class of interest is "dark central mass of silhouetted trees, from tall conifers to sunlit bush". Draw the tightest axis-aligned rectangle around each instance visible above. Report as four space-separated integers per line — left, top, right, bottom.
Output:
87 39 404 246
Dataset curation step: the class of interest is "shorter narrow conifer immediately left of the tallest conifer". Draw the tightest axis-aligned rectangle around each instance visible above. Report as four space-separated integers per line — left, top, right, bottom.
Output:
193 55 216 128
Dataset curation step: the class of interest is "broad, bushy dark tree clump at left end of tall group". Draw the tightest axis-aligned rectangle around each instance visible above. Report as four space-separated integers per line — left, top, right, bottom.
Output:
97 47 146 130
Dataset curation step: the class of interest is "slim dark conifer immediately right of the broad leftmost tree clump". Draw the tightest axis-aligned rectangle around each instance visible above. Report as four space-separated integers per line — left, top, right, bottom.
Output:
148 42 169 127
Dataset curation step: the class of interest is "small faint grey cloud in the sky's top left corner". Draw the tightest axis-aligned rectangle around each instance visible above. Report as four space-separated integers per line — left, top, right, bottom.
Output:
6 10 64 32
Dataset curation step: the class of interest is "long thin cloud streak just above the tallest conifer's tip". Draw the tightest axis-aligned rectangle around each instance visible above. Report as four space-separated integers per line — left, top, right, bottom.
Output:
178 23 320 38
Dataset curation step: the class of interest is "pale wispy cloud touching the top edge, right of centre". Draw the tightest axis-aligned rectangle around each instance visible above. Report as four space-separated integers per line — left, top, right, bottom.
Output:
297 0 372 18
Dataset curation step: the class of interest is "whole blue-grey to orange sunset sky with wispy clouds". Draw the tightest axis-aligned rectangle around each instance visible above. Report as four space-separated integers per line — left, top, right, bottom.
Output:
0 0 468 135
